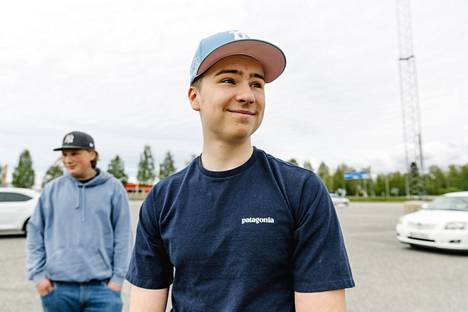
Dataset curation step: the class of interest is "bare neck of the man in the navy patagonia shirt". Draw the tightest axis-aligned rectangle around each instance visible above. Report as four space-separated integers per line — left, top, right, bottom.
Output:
201 138 253 171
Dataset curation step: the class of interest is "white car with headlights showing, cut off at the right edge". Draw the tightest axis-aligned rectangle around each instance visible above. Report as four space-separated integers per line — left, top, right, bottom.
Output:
396 192 468 251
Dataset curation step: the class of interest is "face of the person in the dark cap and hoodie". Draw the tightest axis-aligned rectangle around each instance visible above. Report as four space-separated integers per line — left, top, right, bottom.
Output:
62 149 96 179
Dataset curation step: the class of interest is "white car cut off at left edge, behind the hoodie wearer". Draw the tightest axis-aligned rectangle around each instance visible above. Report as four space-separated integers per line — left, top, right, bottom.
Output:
0 187 39 234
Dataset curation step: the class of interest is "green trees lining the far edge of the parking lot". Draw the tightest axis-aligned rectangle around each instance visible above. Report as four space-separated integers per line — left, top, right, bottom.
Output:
0 150 468 196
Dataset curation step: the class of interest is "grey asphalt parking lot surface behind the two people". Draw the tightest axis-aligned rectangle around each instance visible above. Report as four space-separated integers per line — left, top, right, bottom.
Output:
0 201 468 312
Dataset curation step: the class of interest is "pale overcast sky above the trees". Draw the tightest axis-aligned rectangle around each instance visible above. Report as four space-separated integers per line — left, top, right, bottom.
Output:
0 0 468 184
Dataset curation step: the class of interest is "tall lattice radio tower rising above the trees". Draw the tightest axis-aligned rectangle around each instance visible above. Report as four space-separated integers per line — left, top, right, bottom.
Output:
396 0 424 195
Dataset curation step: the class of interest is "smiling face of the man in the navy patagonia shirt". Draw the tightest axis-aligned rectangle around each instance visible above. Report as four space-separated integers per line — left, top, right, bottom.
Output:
189 55 265 143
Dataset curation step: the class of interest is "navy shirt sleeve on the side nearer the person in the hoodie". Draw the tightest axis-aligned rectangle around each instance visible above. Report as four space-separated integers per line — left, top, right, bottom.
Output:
127 188 173 289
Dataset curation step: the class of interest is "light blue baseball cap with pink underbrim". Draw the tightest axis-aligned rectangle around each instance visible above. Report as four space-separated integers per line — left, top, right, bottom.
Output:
190 30 286 84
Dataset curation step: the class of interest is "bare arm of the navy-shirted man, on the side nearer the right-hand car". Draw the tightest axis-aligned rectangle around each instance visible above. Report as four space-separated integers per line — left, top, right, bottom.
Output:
294 289 346 312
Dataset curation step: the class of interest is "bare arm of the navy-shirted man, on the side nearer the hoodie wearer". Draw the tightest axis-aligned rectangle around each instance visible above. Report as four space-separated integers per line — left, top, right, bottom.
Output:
130 285 168 312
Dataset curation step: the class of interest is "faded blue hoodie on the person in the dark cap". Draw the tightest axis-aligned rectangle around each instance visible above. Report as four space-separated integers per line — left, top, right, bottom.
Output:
26 172 131 285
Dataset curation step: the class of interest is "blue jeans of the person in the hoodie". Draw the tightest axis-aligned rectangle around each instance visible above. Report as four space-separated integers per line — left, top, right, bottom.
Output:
41 282 122 312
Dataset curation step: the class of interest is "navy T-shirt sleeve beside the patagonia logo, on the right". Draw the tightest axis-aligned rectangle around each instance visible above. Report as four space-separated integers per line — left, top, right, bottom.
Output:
293 175 354 292
